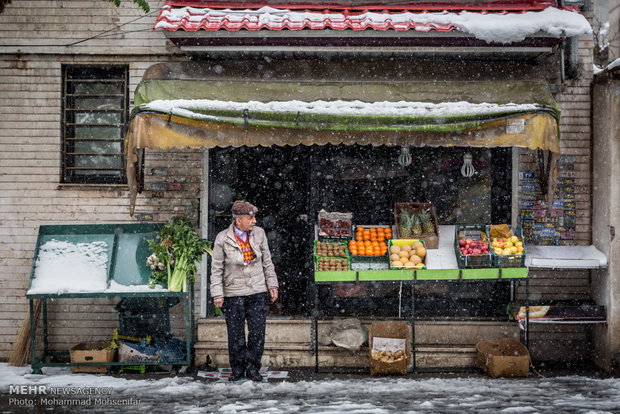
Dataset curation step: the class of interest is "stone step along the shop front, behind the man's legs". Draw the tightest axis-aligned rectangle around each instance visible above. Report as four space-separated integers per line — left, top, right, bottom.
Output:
195 318 519 369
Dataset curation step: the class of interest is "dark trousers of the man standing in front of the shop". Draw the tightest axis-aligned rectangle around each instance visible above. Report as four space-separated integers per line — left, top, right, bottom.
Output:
222 293 267 375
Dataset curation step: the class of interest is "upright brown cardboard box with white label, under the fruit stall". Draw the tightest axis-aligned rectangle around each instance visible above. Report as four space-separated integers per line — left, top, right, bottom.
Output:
368 322 413 375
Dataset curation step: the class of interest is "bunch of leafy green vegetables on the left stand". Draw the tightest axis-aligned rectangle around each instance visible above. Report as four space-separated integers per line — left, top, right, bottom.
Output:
146 217 213 292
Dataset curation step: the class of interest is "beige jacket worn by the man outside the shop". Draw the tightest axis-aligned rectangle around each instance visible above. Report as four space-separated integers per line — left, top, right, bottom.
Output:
211 224 278 298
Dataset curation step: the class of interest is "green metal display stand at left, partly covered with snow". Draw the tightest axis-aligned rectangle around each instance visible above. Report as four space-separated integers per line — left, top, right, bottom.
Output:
26 223 195 374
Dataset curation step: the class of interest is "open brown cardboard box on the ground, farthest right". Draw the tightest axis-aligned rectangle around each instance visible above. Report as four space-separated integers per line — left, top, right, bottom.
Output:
476 339 530 378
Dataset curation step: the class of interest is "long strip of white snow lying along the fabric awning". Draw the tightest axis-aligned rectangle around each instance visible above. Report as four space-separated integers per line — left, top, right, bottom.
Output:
142 99 540 118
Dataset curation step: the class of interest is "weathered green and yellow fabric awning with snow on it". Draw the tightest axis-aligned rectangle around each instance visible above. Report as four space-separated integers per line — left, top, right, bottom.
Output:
125 65 560 213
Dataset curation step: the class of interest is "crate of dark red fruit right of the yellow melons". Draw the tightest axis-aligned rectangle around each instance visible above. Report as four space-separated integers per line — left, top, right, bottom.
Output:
454 224 492 269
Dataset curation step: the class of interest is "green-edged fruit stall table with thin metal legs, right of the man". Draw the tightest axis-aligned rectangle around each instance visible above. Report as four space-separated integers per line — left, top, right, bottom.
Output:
311 267 529 372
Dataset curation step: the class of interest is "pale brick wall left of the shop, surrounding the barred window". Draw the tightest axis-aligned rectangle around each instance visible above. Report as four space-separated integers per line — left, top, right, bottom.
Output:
0 1 201 360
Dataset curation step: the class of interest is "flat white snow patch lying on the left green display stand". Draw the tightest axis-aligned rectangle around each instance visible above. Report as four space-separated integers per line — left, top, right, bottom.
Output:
28 240 108 294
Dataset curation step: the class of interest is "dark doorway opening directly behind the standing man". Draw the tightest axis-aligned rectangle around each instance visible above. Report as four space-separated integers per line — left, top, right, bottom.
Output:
209 146 314 317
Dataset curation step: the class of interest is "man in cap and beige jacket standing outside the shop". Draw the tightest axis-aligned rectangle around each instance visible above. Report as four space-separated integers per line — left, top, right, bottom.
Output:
211 200 278 381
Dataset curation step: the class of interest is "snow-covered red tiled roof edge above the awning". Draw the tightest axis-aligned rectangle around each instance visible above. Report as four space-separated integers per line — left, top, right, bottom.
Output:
154 5 592 43
